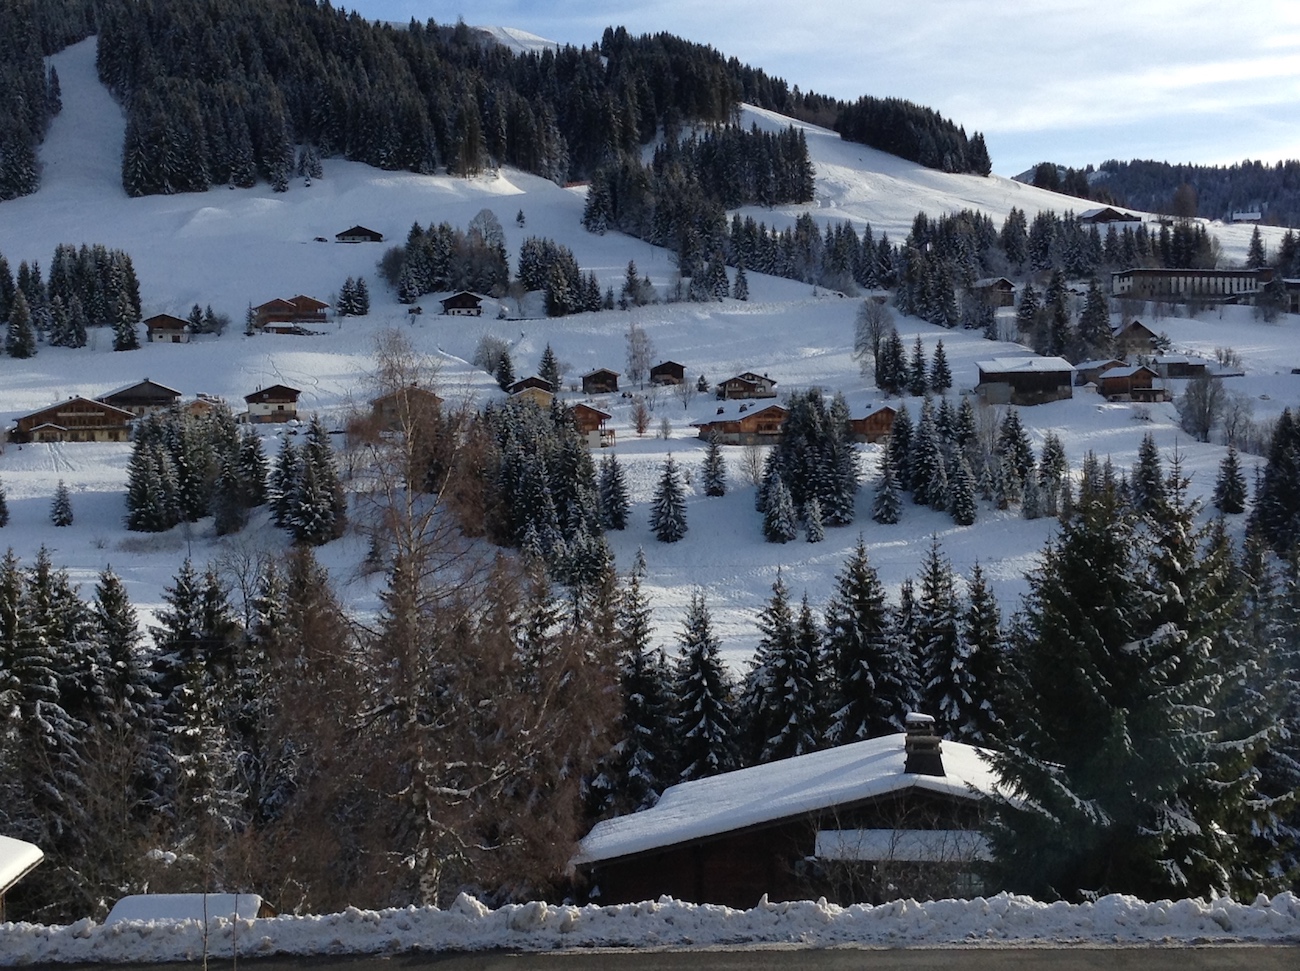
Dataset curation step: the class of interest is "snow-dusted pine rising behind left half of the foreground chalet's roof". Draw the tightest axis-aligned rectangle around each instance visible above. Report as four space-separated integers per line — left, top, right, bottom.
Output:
673 590 740 783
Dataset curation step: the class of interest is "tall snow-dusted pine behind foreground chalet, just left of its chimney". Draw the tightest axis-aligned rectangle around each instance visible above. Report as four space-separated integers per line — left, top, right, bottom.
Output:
826 537 917 745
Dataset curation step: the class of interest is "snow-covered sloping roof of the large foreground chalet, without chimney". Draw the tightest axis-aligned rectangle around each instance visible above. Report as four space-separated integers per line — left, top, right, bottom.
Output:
572 733 997 864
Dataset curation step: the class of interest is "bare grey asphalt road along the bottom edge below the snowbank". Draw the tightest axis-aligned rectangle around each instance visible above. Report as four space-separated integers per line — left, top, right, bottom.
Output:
20 944 1300 971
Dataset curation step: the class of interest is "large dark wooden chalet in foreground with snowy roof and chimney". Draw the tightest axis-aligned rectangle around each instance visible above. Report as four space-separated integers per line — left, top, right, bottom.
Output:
572 715 1001 907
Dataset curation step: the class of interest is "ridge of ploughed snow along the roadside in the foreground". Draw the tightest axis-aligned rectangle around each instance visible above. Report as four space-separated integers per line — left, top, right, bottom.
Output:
0 893 1300 966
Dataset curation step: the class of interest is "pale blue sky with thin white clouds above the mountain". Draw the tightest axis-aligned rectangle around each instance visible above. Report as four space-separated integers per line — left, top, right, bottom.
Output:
337 0 1300 175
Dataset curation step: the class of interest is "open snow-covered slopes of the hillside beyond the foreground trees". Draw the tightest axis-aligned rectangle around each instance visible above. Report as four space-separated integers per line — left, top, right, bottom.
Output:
0 39 1300 668
